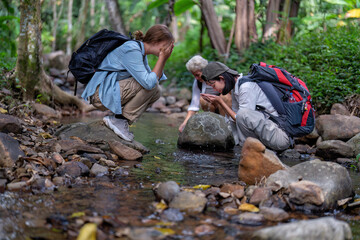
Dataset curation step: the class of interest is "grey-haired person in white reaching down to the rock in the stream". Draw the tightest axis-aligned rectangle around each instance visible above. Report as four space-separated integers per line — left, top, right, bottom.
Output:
179 55 231 132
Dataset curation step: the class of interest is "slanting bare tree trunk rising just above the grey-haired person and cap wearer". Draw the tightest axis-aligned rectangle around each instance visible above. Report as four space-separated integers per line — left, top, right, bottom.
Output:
200 0 226 56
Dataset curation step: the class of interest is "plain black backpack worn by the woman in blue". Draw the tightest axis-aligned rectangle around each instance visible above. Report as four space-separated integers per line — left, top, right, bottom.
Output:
69 29 141 95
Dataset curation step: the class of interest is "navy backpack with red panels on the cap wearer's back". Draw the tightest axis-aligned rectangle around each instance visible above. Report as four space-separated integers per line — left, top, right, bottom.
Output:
239 62 315 137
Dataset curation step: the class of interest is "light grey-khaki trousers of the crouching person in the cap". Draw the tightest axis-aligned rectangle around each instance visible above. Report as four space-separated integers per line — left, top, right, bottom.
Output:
234 108 291 151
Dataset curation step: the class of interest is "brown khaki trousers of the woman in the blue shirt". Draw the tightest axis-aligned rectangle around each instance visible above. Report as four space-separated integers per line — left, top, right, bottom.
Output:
90 77 160 124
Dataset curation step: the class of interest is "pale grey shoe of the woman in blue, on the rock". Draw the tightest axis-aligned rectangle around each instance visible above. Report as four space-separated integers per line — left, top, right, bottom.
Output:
103 116 134 142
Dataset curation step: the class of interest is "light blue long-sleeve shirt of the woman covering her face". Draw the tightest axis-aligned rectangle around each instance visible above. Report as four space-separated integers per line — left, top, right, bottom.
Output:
81 41 166 114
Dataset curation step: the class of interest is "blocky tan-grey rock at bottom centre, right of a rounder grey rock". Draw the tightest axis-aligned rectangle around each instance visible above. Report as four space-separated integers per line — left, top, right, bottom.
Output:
169 191 207 213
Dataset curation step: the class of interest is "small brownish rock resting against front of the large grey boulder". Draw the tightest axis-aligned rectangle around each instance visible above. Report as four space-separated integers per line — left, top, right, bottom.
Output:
289 180 325 205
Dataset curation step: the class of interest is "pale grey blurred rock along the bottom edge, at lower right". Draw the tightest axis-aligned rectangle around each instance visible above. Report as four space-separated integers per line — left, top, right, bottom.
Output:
253 217 352 240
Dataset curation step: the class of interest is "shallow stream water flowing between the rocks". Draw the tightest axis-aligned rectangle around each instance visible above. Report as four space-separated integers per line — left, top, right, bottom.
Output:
0 113 360 240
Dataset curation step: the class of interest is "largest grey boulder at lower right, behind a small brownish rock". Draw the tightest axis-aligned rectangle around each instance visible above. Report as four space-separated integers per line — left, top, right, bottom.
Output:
266 159 353 210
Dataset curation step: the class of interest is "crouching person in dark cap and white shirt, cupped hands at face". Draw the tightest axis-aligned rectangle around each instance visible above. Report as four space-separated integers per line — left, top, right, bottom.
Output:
201 62 291 151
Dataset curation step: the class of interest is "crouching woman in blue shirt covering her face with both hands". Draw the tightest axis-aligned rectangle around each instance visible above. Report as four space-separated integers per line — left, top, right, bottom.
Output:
81 24 174 141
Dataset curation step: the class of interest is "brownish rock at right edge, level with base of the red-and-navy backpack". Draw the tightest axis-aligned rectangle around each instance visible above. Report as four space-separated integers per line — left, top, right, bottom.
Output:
316 115 360 141
